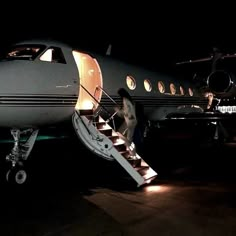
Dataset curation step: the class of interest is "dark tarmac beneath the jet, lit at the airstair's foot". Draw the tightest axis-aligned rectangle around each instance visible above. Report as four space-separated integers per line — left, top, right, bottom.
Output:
0 132 236 236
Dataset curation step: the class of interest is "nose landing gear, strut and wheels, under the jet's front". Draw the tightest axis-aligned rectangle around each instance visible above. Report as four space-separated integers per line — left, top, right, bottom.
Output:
6 129 38 184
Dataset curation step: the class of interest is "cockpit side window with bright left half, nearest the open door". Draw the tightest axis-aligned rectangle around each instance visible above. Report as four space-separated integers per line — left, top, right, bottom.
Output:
39 47 66 64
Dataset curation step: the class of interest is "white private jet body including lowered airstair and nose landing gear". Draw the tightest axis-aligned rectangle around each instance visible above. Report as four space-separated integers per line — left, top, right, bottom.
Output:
0 40 213 186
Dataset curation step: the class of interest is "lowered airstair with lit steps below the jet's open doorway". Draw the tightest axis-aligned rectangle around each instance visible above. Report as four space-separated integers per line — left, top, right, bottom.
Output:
72 85 157 187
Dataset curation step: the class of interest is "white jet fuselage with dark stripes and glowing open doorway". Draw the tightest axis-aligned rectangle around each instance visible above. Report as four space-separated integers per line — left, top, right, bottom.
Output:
0 41 206 129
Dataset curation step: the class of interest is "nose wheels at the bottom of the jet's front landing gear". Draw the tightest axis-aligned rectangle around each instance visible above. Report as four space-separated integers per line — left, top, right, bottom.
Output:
6 168 27 184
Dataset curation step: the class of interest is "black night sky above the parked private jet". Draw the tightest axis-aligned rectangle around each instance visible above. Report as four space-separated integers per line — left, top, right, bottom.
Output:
0 1 236 70
